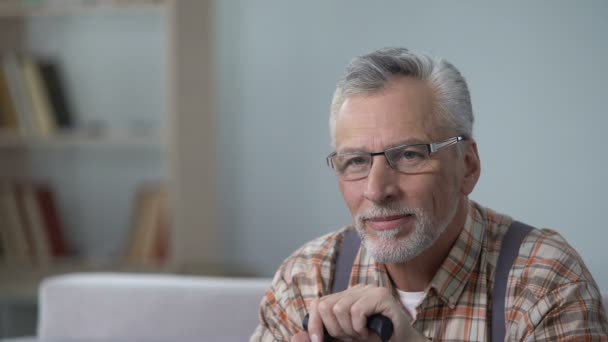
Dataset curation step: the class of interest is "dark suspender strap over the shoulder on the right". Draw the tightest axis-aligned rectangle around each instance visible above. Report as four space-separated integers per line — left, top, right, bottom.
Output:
491 221 533 342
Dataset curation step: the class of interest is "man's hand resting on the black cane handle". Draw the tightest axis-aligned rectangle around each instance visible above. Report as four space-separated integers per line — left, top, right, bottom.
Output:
291 285 426 342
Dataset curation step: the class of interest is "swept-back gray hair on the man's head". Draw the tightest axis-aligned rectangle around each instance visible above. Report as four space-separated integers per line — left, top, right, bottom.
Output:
329 48 474 146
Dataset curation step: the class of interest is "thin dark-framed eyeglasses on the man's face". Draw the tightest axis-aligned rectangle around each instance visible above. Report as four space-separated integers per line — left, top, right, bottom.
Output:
327 135 467 181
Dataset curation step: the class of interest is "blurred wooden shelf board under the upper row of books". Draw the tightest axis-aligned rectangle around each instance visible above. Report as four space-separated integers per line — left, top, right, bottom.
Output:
0 130 167 148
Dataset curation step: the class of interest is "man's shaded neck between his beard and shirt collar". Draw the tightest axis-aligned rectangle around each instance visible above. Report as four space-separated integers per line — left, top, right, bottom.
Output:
386 198 469 292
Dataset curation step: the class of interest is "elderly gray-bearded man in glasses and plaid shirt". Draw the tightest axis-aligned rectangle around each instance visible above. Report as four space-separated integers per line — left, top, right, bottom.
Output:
251 48 608 342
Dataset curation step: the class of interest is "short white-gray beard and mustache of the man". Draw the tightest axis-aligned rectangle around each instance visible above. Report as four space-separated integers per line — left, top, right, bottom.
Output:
355 199 460 264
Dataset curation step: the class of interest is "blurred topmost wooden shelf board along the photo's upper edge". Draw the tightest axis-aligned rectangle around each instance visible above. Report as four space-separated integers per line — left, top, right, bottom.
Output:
0 0 165 18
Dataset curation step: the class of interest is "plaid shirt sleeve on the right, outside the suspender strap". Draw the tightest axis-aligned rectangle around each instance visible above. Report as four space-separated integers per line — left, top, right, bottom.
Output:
507 229 608 341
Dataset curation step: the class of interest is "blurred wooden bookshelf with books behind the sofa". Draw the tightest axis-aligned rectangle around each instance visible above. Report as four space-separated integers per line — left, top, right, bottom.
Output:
0 0 218 337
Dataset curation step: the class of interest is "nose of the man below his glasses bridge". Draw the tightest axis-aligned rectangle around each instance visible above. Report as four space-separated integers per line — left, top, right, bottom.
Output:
363 155 399 203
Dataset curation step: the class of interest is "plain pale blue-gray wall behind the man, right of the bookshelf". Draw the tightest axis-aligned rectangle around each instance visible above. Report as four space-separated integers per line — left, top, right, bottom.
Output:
216 0 608 291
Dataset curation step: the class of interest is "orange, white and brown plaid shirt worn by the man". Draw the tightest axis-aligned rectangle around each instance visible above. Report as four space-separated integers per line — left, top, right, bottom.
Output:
250 201 608 341
